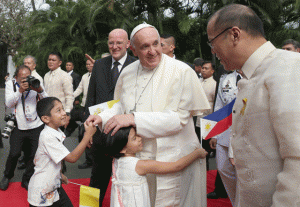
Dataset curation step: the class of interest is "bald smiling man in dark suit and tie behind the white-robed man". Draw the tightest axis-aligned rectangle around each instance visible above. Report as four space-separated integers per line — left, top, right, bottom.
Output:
85 29 136 206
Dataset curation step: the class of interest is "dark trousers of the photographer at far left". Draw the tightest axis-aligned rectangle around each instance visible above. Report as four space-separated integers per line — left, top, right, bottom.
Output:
4 124 44 182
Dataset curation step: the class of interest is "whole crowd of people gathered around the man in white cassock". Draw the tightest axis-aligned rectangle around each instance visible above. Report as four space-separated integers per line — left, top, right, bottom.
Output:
0 4 300 207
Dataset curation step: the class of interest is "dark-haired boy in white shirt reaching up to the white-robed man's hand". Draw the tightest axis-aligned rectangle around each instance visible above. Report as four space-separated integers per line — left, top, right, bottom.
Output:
28 97 96 207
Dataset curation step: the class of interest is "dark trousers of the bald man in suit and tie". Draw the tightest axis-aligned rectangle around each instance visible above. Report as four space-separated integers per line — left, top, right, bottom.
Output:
90 130 112 206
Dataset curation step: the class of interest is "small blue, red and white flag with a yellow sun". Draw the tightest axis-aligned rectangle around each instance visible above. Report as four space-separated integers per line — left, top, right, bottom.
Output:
201 99 235 140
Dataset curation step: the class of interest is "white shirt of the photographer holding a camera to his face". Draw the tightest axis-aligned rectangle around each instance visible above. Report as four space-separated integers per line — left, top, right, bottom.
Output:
5 81 48 130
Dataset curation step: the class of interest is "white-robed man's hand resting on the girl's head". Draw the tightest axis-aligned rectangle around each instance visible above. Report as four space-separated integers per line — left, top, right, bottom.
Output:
104 114 135 136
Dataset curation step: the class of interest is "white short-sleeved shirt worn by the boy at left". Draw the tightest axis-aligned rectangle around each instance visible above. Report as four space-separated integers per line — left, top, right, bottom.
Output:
28 125 70 206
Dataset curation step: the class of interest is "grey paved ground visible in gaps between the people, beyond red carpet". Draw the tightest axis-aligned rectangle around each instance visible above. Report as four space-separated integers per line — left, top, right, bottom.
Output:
0 88 216 182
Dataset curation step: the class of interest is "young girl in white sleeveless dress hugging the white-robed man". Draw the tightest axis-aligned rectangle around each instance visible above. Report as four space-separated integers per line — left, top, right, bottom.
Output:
103 127 207 207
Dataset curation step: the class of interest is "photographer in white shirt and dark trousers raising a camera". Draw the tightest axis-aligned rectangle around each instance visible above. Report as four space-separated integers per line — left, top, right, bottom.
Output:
0 65 48 190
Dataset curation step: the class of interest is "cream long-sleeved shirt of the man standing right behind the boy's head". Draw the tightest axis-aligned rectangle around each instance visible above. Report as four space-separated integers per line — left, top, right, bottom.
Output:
44 67 74 112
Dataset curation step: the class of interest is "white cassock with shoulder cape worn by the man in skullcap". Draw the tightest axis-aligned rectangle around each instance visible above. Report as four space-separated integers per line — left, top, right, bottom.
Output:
100 55 210 207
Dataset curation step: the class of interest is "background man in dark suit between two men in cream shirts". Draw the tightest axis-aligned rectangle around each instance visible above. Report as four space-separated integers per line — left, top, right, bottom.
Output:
65 61 81 137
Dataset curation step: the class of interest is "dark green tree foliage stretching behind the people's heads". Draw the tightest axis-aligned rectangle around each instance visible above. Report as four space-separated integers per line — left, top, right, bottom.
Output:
0 0 300 75
